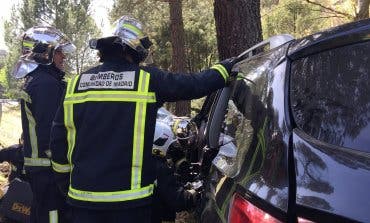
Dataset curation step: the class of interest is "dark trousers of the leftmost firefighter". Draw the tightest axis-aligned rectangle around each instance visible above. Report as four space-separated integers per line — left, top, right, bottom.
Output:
27 168 70 223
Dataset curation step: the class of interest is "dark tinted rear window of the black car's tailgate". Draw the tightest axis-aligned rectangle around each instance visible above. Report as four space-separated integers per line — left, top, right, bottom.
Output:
290 41 370 152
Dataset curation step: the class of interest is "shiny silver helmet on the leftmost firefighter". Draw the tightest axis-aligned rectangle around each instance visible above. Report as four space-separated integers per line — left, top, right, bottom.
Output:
12 26 76 78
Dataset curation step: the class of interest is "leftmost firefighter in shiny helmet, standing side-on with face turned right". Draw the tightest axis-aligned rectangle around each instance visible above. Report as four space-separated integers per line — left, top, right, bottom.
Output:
13 26 75 223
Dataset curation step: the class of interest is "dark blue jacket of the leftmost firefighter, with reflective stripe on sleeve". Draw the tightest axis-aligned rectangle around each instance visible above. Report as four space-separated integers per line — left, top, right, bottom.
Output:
21 65 65 172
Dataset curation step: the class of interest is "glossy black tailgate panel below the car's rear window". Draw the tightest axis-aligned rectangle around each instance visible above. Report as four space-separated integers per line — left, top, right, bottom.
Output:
293 129 370 222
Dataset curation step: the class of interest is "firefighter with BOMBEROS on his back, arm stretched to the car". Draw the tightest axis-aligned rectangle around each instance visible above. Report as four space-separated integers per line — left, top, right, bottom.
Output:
51 16 231 223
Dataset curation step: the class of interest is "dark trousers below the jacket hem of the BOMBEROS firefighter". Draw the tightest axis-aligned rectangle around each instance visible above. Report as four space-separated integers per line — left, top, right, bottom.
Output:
72 206 152 223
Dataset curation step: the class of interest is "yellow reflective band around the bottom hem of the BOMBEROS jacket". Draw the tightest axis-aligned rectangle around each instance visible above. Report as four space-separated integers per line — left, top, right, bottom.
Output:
68 184 153 202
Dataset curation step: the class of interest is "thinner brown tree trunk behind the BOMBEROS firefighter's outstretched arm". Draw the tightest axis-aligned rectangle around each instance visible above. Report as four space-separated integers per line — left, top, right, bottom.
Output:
169 0 190 116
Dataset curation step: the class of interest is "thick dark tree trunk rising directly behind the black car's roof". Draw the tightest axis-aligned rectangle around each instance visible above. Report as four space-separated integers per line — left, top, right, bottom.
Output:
214 0 262 60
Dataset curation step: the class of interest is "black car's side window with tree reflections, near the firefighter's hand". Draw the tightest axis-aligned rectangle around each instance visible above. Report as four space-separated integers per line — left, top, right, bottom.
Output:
217 47 286 176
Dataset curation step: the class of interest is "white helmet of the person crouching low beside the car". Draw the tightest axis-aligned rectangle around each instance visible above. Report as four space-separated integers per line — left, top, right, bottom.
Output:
153 120 176 156
